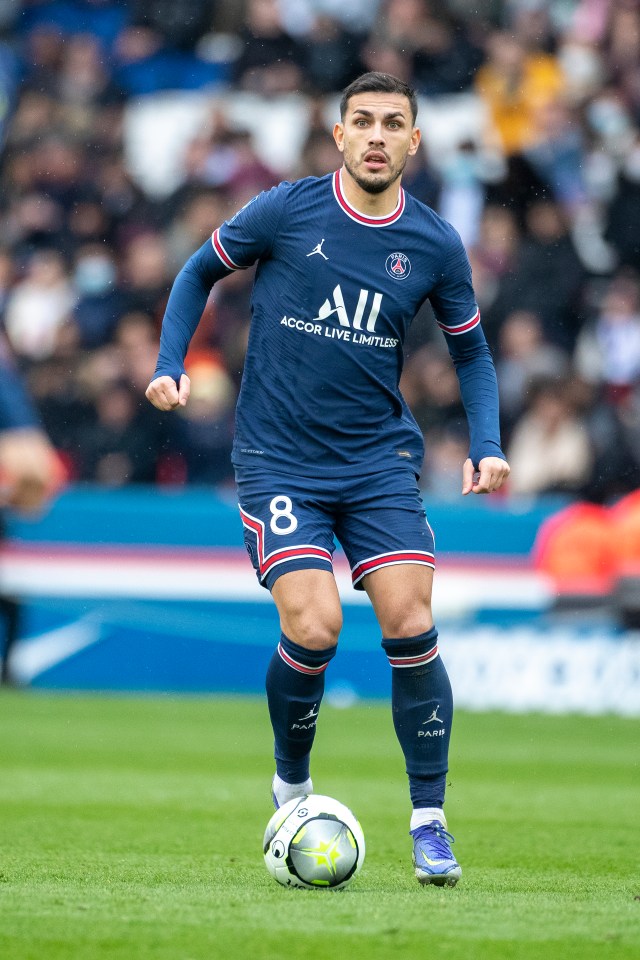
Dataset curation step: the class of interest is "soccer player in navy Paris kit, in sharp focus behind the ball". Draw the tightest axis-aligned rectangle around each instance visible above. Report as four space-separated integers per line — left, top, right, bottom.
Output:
147 73 509 886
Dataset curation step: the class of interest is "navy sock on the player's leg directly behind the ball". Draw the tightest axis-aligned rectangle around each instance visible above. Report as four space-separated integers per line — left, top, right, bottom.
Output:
266 634 337 788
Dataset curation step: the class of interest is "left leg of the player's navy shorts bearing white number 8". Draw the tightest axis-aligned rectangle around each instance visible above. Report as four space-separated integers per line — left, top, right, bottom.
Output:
236 468 335 590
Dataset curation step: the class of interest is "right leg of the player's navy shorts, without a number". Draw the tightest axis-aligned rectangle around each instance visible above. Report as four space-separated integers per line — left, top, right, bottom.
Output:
335 467 435 590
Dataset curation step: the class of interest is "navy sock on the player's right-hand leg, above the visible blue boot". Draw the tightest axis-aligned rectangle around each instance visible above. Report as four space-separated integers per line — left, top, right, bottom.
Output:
382 627 453 808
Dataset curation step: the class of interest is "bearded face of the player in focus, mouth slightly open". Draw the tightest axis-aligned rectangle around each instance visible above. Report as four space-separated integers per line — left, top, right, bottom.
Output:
333 93 420 193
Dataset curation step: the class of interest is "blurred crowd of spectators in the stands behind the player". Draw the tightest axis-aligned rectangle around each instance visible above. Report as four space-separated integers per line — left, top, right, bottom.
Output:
0 0 640 502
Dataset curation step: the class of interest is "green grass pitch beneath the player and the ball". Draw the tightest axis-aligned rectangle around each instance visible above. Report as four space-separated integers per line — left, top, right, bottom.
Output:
0 691 640 960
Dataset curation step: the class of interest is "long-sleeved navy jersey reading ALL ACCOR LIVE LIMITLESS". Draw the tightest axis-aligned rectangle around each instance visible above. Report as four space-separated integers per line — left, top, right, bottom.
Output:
156 172 503 476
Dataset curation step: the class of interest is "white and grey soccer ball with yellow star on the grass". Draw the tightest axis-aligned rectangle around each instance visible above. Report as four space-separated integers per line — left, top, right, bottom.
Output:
263 793 364 890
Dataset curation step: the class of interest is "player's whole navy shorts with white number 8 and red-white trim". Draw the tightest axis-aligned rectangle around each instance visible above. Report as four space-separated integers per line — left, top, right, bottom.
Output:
236 466 435 590
